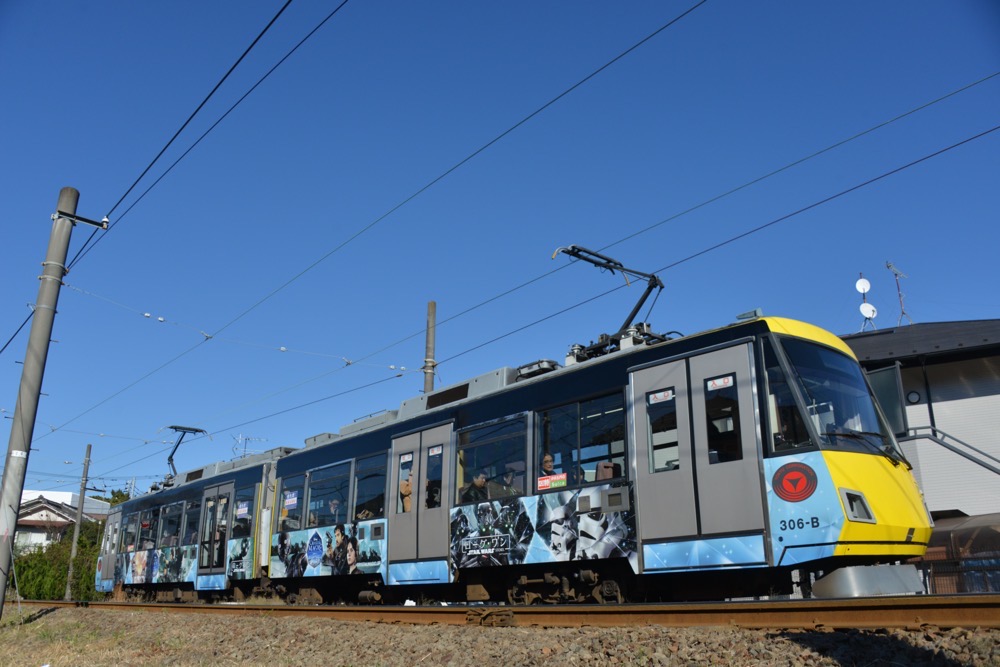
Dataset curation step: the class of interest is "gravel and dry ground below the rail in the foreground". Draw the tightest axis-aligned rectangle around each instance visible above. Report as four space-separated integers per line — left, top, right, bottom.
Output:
0 604 1000 667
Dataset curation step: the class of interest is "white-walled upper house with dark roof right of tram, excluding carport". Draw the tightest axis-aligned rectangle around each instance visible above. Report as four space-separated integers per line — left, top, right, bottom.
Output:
842 320 1000 518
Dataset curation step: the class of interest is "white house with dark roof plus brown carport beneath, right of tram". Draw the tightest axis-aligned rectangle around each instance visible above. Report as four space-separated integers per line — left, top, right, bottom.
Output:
842 320 1000 593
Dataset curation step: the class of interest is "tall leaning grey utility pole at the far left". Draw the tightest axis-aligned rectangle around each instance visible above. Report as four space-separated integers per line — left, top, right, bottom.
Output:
0 188 80 616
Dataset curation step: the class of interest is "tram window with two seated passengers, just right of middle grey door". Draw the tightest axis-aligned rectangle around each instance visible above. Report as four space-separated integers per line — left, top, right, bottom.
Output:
455 415 527 503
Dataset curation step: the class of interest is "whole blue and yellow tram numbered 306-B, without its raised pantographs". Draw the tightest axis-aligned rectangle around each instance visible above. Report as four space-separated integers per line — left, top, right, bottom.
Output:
96 317 933 604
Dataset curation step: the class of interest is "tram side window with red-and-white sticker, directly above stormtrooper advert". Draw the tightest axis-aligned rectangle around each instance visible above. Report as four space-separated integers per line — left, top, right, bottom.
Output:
537 394 625 491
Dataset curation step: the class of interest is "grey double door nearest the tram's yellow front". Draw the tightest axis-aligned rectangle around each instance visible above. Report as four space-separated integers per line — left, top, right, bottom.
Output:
630 342 764 541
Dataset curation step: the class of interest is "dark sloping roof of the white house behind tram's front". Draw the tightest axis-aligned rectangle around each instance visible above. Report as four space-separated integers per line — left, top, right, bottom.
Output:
841 320 1000 365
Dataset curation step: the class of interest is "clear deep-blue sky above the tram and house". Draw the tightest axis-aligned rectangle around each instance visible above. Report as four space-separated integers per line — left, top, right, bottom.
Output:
0 0 1000 490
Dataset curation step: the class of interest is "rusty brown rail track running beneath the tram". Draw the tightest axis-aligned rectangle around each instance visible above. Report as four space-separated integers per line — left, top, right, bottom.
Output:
17 595 1000 630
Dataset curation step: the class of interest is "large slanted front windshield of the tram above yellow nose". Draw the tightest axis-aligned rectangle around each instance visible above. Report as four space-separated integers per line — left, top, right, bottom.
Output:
781 338 906 464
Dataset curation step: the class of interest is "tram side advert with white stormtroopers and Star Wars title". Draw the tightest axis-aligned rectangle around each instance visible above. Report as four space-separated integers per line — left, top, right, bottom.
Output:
451 484 639 575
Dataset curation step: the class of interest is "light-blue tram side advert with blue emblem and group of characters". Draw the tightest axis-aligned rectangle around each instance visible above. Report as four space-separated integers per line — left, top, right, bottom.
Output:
270 519 386 579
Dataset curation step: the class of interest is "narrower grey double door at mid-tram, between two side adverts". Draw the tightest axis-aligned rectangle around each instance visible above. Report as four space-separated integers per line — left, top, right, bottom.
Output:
388 423 454 562
